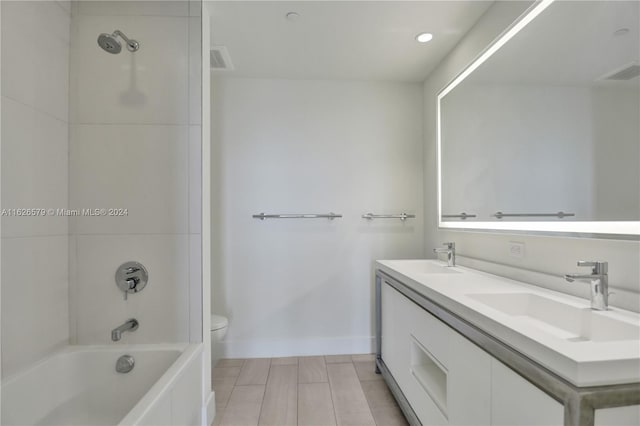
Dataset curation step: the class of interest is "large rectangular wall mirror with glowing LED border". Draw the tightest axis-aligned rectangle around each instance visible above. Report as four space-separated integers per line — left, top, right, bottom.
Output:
438 1 640 239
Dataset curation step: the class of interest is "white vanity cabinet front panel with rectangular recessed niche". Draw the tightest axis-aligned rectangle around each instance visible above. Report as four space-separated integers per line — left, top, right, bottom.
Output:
382 285 491 426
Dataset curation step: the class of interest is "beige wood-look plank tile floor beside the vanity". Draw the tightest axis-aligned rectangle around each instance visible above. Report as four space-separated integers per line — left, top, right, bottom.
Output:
212 355 407 426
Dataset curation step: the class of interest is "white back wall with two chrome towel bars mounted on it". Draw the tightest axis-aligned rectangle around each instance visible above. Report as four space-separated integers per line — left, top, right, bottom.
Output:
212 78 424 357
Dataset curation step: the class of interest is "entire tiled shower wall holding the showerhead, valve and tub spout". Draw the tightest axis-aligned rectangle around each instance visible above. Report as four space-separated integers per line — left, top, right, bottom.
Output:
69 1 202 344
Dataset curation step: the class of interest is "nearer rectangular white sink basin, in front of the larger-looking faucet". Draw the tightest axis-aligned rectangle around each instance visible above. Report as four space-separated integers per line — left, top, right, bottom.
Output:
467 292 640 342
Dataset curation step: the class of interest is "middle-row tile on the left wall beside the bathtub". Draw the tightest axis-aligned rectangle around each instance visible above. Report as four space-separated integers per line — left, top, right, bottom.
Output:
2 96 68 237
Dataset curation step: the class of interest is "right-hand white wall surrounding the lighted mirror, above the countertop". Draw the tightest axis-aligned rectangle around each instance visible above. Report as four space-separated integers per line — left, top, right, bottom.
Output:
424 2 640 310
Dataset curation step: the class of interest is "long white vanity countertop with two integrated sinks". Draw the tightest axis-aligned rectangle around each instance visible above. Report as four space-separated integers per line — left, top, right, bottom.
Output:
376 260 640 387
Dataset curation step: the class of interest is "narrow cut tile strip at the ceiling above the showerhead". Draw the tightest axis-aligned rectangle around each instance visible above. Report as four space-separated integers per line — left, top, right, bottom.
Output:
78 0 189 16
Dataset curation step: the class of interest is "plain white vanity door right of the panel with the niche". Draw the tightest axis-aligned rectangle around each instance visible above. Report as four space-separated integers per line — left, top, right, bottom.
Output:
491 358 564 426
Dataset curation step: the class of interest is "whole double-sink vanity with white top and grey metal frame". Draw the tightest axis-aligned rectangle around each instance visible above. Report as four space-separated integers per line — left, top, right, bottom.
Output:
375 260 640 426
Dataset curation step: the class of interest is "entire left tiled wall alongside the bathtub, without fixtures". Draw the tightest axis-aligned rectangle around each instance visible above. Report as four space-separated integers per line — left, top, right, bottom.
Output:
0 1 70 377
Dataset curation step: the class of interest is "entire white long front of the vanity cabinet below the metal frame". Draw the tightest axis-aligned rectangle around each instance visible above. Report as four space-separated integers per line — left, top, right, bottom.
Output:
381 284 564 426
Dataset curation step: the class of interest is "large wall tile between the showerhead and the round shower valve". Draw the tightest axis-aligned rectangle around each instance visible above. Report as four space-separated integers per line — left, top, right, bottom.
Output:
70 125 189 234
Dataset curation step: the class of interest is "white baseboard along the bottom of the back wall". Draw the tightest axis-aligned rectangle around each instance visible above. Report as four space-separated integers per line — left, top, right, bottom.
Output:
218 336 375 358
